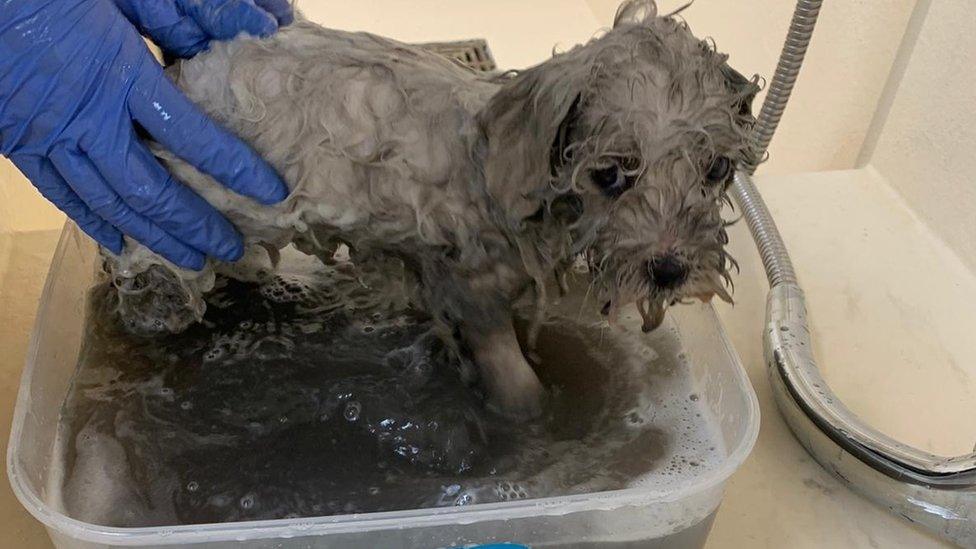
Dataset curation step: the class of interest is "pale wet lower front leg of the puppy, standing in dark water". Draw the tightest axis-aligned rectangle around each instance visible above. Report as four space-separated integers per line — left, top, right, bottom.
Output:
464 317 545 419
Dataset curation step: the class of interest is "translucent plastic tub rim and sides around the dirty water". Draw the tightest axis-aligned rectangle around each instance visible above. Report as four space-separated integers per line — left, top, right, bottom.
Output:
7 224 759 549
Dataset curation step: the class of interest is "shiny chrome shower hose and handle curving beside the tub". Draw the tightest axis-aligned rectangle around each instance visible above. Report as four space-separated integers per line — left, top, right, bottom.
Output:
731 0 976 547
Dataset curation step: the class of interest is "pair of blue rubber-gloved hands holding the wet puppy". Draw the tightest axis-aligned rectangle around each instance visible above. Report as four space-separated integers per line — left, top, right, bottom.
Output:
0 0 291 269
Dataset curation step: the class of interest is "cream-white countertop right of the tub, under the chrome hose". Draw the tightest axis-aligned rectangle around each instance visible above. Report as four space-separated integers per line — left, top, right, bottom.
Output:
707 169 964 549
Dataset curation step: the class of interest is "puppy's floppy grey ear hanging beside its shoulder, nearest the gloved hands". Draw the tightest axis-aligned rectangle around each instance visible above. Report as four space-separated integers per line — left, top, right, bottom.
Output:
479 60 582 229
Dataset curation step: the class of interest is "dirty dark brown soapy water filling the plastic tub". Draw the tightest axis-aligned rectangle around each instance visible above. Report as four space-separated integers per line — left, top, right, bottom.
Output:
53 256 724 527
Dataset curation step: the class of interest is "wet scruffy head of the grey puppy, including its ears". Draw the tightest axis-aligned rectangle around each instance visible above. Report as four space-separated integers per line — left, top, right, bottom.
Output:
482 0 758 330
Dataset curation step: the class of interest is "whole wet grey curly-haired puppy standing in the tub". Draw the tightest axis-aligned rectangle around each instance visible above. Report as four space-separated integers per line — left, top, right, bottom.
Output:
106 0 758 415
